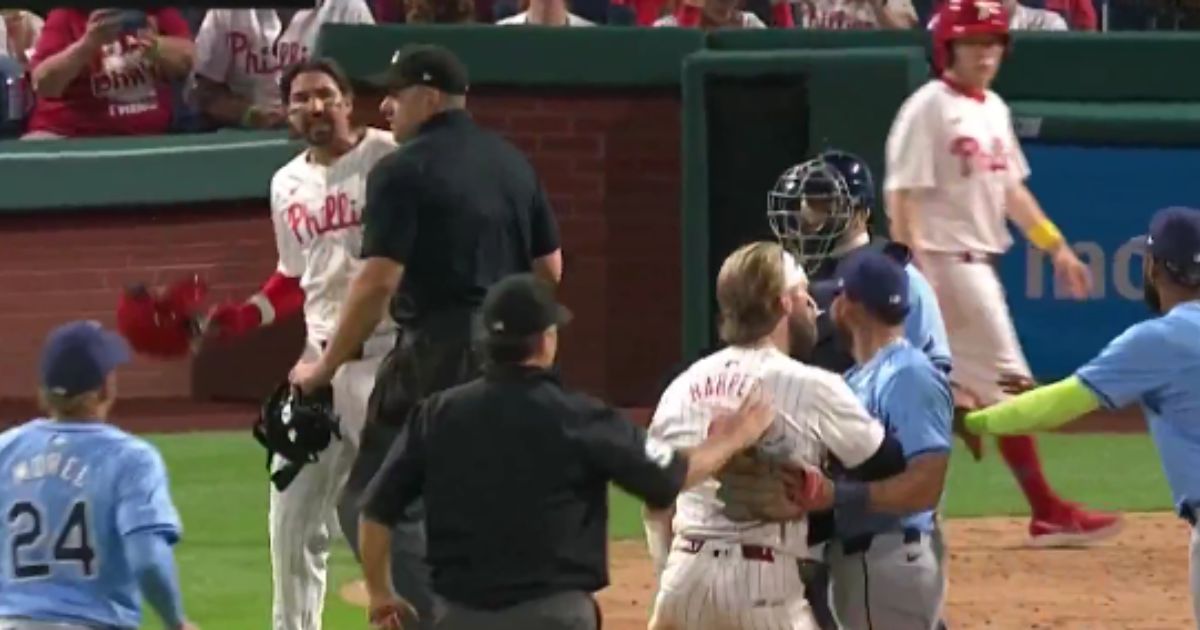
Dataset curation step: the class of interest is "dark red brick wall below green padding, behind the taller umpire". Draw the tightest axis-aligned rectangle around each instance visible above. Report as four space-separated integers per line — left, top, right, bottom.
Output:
0 90 680 404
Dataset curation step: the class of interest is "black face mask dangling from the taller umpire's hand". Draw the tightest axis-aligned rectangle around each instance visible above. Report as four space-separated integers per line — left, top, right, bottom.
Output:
253 382 342 492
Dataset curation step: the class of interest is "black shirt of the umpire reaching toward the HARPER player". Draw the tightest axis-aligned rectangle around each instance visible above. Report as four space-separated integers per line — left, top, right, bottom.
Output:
364 367 688 610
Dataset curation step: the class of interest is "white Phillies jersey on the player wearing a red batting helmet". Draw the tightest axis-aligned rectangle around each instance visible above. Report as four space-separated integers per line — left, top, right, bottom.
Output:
883 79 1030 253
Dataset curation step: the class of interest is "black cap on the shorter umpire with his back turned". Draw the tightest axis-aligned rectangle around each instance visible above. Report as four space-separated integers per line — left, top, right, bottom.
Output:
482 274 571 338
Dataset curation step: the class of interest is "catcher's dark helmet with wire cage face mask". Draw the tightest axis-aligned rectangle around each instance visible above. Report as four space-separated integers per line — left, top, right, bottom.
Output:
767 150 875 275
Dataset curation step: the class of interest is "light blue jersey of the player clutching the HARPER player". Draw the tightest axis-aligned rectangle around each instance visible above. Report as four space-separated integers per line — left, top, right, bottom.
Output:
838 340 954 540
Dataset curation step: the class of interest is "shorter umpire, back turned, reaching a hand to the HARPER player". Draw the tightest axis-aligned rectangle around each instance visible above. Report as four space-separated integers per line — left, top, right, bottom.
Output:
360 274 774 630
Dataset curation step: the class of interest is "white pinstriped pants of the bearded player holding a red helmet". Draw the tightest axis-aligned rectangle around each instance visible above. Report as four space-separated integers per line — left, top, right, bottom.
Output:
268 335 395 630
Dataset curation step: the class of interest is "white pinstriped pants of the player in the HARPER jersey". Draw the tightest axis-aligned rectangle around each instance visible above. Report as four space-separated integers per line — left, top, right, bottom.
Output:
649 539 817 630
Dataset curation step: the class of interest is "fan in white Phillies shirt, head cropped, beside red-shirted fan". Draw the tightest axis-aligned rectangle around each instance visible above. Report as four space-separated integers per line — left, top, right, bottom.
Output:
191 0 374 128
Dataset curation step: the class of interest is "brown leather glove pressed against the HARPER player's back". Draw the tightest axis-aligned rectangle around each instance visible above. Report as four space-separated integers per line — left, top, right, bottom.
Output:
716 454 804 522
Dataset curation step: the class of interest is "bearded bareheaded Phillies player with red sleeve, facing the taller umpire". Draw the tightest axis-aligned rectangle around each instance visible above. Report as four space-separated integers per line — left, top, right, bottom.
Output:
209 59 427 630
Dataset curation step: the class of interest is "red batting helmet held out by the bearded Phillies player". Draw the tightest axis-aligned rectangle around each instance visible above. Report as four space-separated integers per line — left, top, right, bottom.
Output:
116 276 208 359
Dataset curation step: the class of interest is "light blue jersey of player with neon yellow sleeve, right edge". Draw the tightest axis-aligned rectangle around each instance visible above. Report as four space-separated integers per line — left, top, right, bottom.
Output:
1075 302 1200 508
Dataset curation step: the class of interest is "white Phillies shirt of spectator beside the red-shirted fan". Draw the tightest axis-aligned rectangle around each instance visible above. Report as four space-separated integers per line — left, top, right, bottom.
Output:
196 0 374 107
